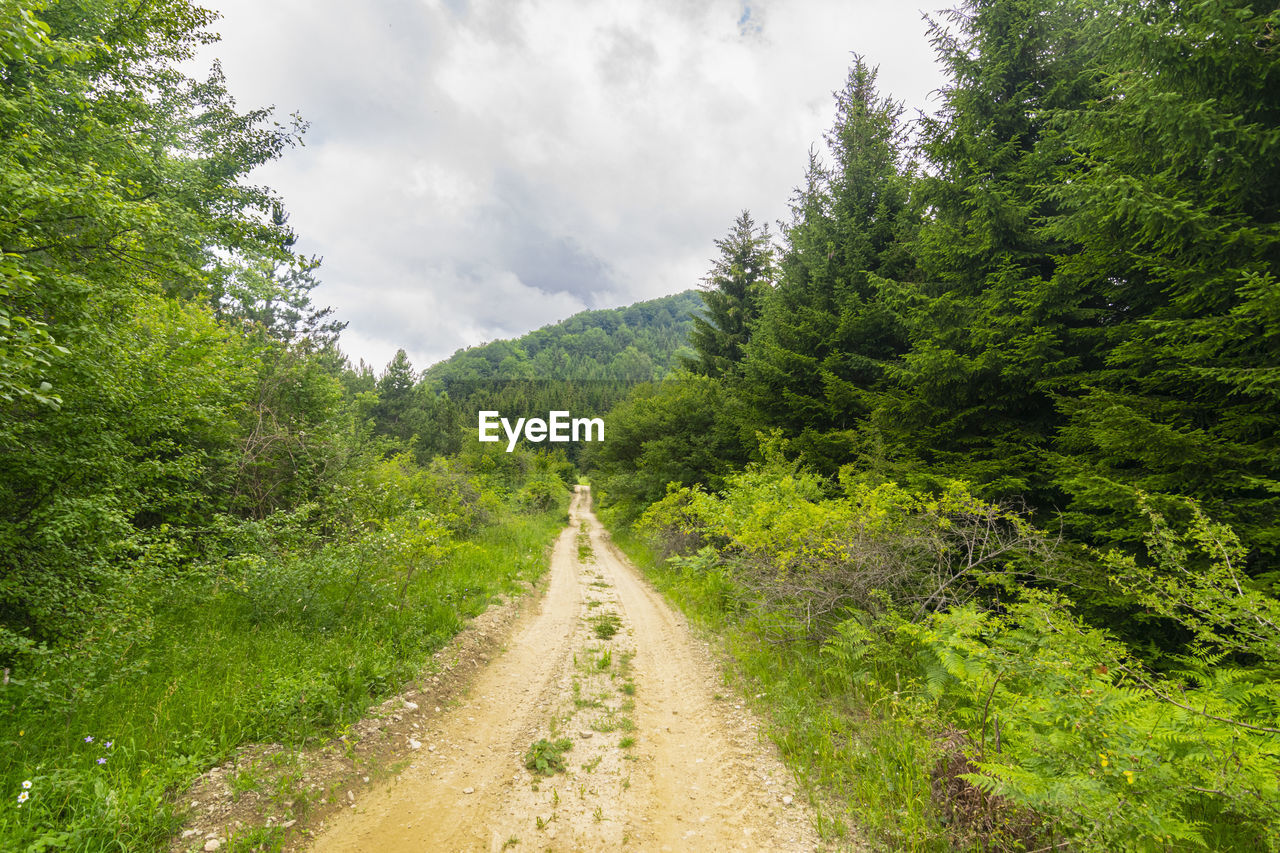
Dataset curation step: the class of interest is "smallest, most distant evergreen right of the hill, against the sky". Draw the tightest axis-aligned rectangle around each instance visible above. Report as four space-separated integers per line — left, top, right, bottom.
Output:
685 210 774 377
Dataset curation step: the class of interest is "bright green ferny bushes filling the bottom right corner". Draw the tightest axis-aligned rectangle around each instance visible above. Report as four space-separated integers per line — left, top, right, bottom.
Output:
824 494 1280 852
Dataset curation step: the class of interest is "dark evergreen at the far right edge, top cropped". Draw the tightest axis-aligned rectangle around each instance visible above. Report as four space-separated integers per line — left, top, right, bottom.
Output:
1052 0 1280 558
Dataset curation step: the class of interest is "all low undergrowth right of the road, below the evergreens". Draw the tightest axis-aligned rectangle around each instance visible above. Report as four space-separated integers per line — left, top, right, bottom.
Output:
606 473 1280 853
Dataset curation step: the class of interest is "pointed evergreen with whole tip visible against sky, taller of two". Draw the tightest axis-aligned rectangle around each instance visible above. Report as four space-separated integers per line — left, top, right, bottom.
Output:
742 58 918 470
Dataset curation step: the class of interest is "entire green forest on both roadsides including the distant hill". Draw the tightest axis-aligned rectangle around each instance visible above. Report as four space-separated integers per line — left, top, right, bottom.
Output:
0 0 1280 853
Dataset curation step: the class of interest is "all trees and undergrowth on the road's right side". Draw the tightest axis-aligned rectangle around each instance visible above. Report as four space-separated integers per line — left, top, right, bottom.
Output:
588 0 1280 850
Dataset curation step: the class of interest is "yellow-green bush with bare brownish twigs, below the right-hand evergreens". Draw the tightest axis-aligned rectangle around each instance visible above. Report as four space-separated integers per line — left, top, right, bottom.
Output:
639 455 1053 637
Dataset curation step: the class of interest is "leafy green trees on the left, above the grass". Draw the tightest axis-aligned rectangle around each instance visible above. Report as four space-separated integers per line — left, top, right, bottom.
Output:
0 0 337 640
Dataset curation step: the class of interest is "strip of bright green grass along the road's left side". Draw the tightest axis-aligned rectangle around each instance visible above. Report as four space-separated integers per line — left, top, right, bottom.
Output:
0 502 564 853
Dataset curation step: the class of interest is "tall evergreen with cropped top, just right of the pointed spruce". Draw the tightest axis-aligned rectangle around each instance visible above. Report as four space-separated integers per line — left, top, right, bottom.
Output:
884 0 1100 506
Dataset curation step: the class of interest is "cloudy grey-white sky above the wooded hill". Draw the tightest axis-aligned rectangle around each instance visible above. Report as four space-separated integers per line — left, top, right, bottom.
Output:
196 0 943 371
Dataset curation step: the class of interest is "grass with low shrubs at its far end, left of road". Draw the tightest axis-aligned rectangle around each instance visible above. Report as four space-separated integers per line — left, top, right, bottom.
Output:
0 450 563 849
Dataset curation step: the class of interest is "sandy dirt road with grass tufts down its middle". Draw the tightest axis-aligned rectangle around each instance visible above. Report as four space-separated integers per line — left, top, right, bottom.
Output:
312 487 818 853
